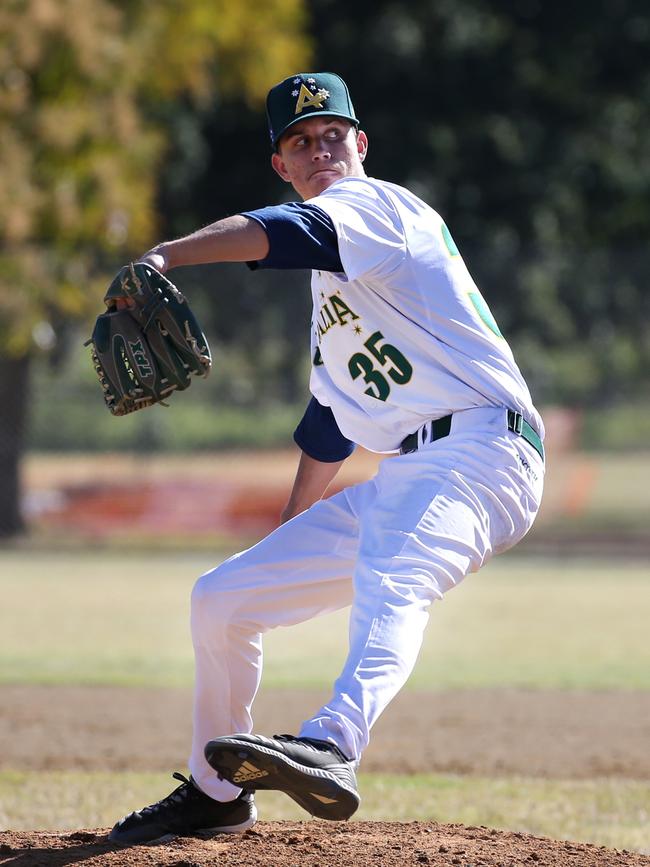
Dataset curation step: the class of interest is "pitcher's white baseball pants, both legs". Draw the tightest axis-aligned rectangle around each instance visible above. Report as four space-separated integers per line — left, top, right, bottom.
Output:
189 408 544 801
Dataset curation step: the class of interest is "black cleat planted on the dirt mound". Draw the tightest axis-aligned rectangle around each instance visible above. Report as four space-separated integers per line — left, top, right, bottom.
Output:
108 773 257 846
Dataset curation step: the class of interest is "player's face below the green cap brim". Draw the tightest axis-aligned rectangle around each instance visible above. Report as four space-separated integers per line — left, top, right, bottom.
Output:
271 116 368 199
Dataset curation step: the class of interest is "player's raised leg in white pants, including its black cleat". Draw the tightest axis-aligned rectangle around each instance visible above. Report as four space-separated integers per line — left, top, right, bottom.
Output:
206 410 543 819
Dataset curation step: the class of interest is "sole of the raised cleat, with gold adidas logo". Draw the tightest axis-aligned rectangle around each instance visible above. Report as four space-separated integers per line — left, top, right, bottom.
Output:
205 741 361 822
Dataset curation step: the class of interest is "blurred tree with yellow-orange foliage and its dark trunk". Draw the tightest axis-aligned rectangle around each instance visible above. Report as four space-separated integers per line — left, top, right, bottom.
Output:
0 0 309 536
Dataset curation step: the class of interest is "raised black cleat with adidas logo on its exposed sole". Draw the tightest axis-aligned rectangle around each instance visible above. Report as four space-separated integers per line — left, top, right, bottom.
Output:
205 734 361 821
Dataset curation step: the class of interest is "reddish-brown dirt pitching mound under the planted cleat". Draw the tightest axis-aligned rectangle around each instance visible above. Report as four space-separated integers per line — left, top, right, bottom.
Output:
0 821 650 867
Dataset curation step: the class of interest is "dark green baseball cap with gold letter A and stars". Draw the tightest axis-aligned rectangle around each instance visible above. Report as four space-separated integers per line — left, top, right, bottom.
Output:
266 72 359 149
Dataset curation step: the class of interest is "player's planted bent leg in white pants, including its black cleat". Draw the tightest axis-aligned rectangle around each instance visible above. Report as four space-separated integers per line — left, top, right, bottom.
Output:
111 485 363 844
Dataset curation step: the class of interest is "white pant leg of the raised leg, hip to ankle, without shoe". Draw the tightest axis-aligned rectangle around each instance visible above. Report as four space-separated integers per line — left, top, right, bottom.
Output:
300 410 543 759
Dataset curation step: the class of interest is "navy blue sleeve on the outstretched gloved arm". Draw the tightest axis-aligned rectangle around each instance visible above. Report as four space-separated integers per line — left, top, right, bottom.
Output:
242 202 343 272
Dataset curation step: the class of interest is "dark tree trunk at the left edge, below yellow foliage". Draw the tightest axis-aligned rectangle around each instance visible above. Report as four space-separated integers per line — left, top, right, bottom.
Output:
0 355 29 539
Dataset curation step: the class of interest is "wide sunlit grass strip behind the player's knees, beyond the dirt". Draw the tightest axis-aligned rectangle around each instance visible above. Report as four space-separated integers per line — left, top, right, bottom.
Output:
0 551 650 690
